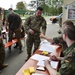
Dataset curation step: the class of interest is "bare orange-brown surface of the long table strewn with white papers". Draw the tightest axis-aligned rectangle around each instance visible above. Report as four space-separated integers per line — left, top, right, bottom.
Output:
16 47 62 75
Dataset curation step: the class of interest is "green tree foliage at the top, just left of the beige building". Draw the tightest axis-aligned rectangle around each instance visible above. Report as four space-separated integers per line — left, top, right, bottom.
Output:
42 0 63 15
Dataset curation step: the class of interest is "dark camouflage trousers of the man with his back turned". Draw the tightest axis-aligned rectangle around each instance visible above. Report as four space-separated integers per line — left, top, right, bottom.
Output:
8 29 22 49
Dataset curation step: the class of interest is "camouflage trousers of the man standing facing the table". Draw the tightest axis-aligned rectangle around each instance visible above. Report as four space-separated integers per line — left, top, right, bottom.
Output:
26 33 40 56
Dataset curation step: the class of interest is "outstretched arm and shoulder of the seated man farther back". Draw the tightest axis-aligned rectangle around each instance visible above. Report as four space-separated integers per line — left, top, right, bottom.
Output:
40 34 68 56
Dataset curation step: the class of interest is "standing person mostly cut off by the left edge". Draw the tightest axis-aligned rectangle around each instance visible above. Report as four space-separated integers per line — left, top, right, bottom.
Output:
0 8 8 70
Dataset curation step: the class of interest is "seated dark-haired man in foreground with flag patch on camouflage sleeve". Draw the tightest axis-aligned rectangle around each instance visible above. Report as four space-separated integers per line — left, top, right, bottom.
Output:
45 21 75 75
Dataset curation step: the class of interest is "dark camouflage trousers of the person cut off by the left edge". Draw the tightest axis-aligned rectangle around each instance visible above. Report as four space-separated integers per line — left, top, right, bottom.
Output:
0 39 5 69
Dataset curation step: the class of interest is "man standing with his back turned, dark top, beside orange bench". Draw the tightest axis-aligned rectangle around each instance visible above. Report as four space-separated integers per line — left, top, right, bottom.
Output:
6 8 22 53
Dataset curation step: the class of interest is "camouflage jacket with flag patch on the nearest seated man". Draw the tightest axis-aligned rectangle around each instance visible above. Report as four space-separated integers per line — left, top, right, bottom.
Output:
57 43 75 75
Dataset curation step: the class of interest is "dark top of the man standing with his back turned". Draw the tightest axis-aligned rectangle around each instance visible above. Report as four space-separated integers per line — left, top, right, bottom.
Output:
6 12 22 30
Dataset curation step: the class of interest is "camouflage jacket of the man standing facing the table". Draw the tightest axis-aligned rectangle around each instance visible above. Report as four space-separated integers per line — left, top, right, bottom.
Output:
24 15 47 34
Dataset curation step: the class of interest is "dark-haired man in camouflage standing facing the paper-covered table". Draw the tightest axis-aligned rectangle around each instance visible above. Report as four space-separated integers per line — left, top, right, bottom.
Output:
25 7 47 59
